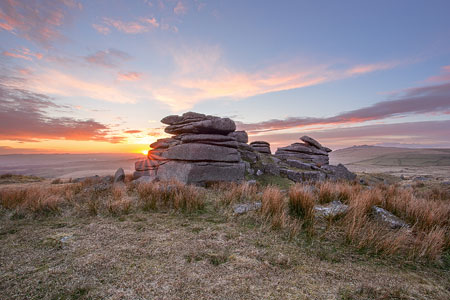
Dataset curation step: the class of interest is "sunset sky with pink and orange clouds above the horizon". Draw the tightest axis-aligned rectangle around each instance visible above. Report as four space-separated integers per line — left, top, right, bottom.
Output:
0 0 450 154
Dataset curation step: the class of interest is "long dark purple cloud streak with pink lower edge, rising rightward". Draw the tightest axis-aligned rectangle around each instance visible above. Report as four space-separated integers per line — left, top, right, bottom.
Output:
239 83 450 132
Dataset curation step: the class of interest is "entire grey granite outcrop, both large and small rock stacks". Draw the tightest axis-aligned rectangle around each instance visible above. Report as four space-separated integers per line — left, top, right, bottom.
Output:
134 112 356 185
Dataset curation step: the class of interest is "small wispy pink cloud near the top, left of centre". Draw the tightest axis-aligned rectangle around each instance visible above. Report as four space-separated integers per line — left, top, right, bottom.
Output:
92 18 159 35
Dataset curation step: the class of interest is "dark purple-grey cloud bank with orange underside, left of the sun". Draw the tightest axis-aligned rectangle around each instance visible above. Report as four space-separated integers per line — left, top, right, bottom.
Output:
0 84 123 143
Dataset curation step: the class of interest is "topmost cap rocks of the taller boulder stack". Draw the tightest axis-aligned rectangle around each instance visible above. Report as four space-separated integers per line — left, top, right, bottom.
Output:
161 112 236 135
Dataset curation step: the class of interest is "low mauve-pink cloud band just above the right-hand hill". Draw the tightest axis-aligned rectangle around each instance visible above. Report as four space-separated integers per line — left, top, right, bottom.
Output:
250 120 450 150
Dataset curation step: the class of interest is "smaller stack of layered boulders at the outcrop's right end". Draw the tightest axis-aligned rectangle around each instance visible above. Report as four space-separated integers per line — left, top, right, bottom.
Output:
275 136 331 168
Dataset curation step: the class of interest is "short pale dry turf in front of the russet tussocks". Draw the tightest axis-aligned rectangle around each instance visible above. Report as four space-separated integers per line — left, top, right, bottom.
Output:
0 181 450 299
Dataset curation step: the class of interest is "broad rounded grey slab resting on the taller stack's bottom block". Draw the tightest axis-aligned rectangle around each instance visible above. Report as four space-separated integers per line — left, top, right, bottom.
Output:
161 143 241 162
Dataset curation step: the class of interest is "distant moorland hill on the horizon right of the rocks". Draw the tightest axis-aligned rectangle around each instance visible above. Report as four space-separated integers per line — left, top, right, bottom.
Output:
330 145 450 167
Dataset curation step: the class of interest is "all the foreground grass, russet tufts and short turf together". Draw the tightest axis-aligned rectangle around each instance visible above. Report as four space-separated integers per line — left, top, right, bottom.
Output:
0 180 450 299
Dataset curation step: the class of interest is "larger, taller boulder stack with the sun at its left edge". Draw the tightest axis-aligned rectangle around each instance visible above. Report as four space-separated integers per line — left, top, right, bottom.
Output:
134 112 248 185
